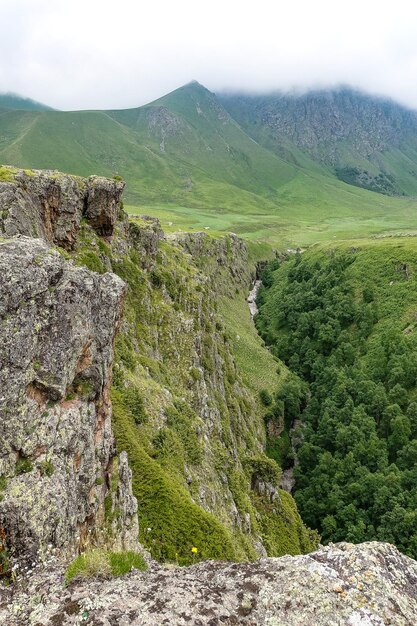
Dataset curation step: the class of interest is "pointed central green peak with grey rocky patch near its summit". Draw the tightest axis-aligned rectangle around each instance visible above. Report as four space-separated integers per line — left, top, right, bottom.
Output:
106 83 296 197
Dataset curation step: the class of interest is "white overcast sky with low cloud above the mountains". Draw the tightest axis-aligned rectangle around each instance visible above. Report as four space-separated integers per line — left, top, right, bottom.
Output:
0 0 417 109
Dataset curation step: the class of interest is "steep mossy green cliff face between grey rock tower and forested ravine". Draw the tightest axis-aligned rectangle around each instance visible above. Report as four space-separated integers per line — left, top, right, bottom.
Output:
76 216 317 564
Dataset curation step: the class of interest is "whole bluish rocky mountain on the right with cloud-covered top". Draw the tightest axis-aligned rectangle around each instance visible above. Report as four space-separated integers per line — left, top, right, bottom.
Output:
219 88 417 195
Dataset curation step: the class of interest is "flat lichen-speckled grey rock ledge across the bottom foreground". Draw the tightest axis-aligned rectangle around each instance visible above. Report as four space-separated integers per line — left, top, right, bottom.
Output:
0 543 417 626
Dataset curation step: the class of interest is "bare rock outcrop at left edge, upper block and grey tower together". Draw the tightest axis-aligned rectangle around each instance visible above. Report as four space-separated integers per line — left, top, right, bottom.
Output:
0 172 138 570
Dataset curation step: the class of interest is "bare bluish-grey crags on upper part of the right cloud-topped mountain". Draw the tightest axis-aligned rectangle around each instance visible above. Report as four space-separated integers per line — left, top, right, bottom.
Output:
220 88 417 165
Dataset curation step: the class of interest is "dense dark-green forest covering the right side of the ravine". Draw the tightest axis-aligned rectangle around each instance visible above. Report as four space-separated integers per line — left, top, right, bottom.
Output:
257 238 417 558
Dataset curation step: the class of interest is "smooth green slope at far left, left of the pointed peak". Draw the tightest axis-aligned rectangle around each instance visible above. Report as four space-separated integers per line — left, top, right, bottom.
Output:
0 111 179 193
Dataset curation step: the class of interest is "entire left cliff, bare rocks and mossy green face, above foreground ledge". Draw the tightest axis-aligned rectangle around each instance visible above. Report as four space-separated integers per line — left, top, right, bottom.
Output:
0 168 317 564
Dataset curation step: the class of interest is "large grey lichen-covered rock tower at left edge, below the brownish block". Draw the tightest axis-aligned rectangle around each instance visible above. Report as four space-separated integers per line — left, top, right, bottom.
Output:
0 236 137 560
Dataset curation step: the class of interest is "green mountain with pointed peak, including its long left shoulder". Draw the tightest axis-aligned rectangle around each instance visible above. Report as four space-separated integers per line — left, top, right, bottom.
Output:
0 83 295 205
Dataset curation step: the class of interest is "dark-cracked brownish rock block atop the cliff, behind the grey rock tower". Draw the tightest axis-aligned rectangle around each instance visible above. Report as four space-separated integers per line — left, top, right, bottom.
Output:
0 170 124 250
